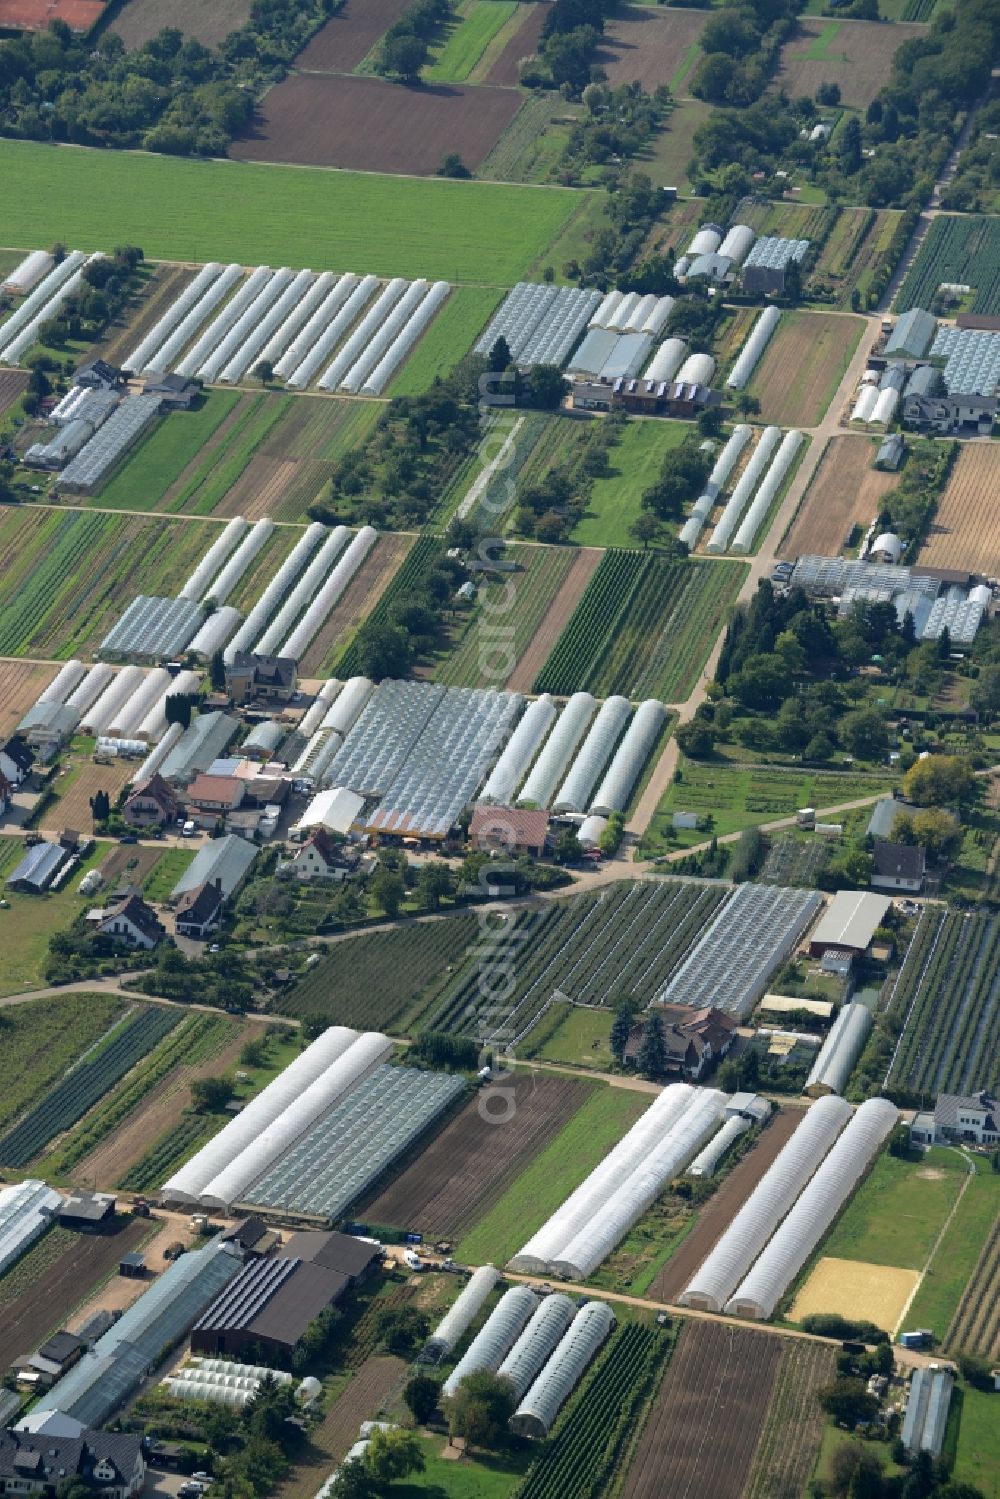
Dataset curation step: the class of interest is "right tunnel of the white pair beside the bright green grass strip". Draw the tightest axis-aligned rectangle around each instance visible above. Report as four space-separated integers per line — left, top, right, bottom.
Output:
552 1088 729 1280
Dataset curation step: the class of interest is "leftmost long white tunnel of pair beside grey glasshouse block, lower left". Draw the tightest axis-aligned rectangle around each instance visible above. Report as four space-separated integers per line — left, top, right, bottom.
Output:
160 1025 361 1204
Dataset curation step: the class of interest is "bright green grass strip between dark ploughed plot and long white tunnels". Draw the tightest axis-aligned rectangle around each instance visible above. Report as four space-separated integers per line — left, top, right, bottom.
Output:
454 1087 651 1265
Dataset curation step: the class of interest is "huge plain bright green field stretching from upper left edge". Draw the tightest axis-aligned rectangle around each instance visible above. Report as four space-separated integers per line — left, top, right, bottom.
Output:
0 141 582 286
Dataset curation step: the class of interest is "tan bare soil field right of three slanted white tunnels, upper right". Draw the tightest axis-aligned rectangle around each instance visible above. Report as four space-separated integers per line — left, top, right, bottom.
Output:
778 436 900 561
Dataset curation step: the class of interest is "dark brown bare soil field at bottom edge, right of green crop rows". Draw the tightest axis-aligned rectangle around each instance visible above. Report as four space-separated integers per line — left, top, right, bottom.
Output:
622 1321 781 1499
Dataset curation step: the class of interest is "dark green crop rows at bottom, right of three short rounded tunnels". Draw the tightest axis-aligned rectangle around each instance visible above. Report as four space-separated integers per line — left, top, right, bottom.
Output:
517 1322 672 1499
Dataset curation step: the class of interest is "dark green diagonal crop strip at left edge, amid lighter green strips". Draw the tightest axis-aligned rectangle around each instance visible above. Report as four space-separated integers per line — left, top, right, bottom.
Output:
0 1006 180 1166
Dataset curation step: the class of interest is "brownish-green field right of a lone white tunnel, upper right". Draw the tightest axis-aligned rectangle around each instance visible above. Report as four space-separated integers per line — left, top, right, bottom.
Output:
750 312 865 427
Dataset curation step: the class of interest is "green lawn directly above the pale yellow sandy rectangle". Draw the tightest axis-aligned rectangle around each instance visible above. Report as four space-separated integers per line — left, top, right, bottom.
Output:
823 1147 966 1271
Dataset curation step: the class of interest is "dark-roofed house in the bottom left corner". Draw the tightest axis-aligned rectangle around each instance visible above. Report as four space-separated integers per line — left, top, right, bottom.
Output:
0 1429 145 1499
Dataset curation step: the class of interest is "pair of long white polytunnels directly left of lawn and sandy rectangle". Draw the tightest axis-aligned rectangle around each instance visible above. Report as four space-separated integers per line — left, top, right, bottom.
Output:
679 1093 900 1321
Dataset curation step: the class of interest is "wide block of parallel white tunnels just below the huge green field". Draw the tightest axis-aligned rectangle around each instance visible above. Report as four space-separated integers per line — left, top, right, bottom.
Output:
113 261 450 396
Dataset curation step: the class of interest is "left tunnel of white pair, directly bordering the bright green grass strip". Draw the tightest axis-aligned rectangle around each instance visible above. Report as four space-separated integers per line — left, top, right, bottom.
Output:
510 1082 694 1276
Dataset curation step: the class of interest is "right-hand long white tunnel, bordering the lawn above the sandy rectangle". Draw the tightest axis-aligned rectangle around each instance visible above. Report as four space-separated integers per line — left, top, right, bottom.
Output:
726 1094 900 1321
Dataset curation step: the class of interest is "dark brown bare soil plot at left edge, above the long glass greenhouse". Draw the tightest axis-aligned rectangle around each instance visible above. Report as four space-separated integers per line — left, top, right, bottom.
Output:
0 1219 150 1363
